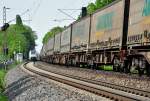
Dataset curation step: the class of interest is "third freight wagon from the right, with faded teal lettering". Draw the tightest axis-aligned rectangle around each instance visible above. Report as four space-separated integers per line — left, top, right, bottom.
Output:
70 16 91 66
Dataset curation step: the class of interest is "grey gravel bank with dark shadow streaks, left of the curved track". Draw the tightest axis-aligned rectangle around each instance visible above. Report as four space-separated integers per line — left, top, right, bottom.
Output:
5 65 110 101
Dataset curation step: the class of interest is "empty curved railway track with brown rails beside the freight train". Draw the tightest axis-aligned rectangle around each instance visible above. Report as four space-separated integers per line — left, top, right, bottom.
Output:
24 63 150 101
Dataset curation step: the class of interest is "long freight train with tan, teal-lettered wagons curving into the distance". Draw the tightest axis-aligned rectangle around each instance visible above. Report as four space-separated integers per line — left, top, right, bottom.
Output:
40 0 150 75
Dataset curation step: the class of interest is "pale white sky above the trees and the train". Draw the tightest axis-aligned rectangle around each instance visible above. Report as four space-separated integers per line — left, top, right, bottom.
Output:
0 0 95 52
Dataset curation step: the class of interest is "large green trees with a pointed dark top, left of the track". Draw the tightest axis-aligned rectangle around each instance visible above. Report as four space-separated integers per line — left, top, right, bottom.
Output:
0 15 37 57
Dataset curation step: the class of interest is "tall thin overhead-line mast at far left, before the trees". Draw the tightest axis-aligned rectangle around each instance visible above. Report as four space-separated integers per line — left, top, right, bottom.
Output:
3 6 10 56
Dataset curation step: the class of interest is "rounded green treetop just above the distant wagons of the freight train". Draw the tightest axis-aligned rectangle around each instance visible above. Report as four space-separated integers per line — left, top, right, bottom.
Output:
42 26 63 44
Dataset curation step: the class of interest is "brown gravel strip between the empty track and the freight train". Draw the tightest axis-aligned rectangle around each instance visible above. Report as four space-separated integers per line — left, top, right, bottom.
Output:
35 62 150 91
